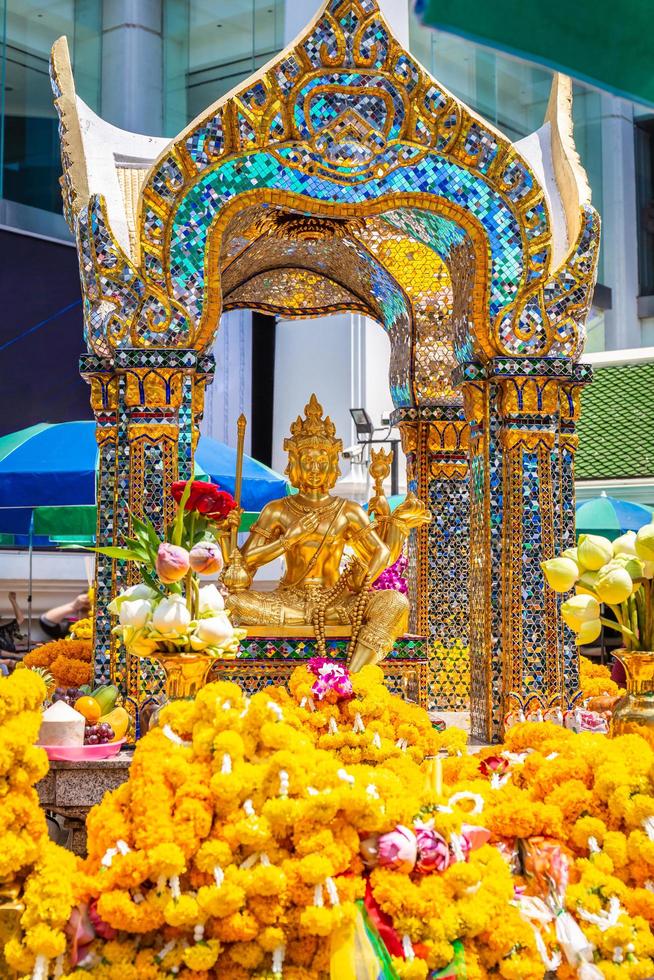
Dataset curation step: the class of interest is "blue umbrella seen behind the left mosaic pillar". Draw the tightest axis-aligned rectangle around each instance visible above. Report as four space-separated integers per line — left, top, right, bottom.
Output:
0 422 288 533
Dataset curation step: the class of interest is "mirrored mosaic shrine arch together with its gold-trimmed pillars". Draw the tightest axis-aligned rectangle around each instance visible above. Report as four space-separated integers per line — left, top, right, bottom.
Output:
51 0 599 738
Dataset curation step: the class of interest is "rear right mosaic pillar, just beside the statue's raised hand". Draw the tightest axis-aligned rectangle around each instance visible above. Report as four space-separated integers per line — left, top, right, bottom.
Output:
393 404 469 710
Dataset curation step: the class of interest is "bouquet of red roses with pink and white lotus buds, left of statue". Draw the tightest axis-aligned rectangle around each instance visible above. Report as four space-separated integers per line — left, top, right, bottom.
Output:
96 480 245 658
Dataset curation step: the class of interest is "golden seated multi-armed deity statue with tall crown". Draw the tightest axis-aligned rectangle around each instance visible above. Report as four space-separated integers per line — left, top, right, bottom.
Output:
223 395 431 670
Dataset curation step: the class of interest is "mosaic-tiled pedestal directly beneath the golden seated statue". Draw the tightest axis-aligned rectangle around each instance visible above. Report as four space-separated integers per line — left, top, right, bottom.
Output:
208 626 436 708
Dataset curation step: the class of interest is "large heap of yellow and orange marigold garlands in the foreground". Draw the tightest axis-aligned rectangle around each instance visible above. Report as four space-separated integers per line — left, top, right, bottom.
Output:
6 661 654 980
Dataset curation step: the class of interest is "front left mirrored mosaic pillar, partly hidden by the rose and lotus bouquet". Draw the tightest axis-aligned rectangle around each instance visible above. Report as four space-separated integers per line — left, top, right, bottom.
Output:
80 349 214 697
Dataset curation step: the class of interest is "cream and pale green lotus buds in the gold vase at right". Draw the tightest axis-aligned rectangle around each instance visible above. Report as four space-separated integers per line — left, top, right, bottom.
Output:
542 522 654 651
